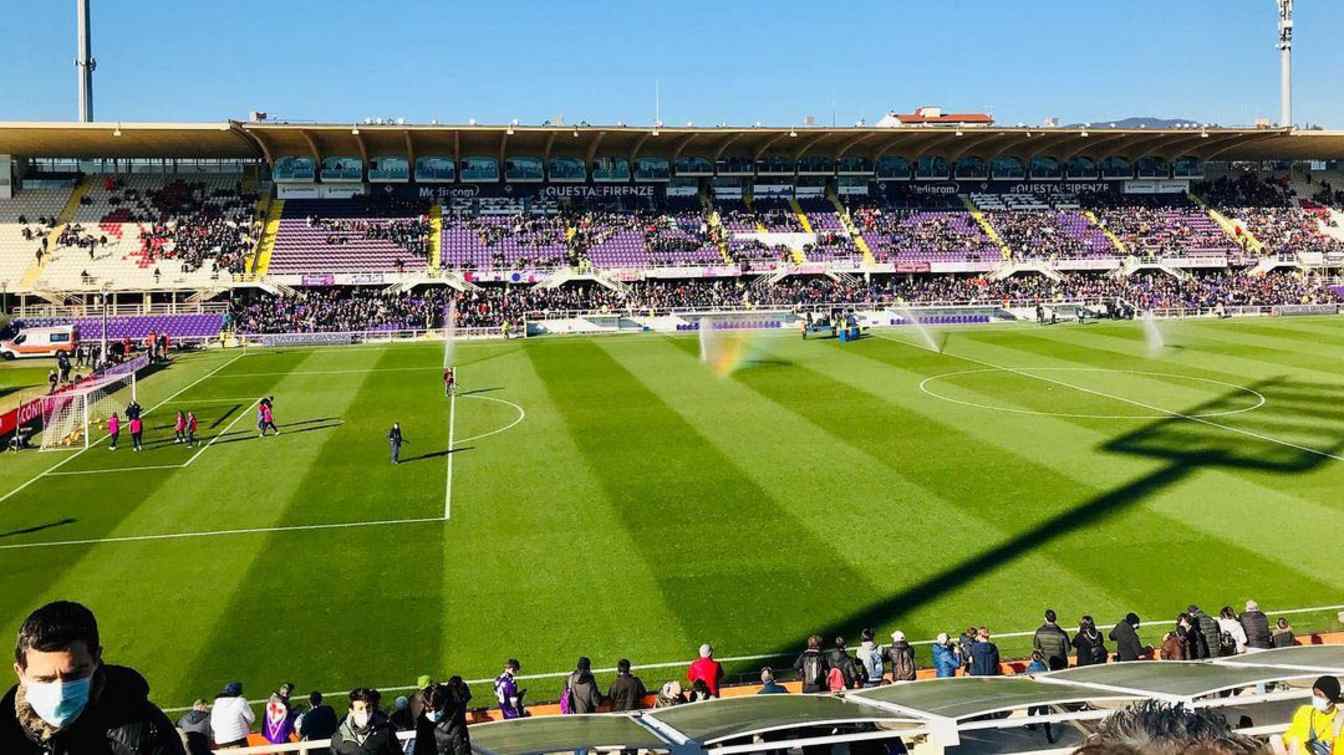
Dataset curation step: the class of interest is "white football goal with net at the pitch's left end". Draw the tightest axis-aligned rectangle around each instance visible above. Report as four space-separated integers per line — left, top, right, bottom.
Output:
42 356 149 451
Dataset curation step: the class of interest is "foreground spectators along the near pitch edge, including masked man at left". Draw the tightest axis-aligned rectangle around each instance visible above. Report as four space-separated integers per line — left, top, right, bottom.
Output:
0 601 1344 755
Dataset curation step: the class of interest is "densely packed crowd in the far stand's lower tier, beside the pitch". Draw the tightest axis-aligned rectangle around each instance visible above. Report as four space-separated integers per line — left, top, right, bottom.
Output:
231 273 1341 333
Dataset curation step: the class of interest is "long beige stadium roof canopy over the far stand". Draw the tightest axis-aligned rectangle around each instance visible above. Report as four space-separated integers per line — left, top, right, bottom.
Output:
0 121 1344 161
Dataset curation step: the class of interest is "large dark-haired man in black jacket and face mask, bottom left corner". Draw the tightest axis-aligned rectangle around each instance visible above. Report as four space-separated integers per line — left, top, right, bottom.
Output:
0 601 185 755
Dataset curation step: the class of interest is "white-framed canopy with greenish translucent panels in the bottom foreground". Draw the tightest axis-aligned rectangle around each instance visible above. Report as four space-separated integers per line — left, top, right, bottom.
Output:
220 645 1344 755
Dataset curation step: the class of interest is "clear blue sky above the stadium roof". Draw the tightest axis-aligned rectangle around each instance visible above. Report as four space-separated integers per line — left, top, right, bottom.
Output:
0 0 1344 128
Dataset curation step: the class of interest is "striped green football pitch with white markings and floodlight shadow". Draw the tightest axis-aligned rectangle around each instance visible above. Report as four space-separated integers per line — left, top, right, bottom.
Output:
0 313 1344 707
